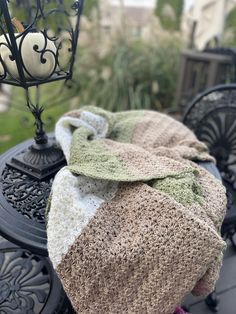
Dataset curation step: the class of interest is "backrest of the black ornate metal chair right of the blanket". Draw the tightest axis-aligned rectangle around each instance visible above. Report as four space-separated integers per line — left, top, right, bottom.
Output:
184 86 236 189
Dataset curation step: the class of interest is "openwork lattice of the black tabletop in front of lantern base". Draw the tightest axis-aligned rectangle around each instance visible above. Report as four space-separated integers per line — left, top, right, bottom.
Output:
0 166 53 223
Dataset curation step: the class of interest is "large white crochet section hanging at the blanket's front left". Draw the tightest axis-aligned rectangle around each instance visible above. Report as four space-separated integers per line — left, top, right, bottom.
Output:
47 168 118 268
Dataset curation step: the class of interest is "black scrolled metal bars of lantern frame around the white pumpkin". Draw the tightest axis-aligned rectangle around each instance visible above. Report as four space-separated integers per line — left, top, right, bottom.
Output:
0 0 83 89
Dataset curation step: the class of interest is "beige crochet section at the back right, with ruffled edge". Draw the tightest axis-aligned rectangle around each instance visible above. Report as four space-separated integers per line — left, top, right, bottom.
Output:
131 111 214 161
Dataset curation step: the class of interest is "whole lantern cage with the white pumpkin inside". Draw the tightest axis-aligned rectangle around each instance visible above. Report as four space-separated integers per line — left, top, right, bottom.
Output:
0 0 83 88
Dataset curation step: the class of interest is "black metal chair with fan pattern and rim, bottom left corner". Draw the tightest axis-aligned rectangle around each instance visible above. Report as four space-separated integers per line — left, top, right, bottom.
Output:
0 237 75 314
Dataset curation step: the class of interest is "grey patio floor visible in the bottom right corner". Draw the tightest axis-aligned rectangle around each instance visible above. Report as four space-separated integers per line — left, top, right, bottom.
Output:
185 239 236 314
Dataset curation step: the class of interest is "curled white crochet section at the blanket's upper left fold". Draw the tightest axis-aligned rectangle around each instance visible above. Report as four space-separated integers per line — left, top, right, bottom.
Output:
55 111 108 162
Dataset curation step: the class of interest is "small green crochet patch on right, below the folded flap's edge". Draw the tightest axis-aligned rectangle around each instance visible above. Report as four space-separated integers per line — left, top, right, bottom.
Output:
152 173 204 205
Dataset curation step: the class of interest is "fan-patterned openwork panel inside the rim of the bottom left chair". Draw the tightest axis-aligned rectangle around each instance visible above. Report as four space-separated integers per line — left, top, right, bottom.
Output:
0 248 51 314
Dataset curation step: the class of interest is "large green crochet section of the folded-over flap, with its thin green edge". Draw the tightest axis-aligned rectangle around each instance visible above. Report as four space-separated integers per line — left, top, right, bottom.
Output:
68 122 195 182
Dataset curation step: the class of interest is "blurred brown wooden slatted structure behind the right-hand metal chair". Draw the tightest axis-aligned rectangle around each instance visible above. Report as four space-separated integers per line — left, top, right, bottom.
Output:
176 50 235 112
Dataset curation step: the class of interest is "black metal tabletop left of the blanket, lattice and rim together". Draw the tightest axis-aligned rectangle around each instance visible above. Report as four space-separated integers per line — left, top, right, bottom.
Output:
0 135 54 256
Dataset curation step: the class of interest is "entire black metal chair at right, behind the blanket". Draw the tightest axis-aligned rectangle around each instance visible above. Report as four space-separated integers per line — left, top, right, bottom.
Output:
183 84 236 312
